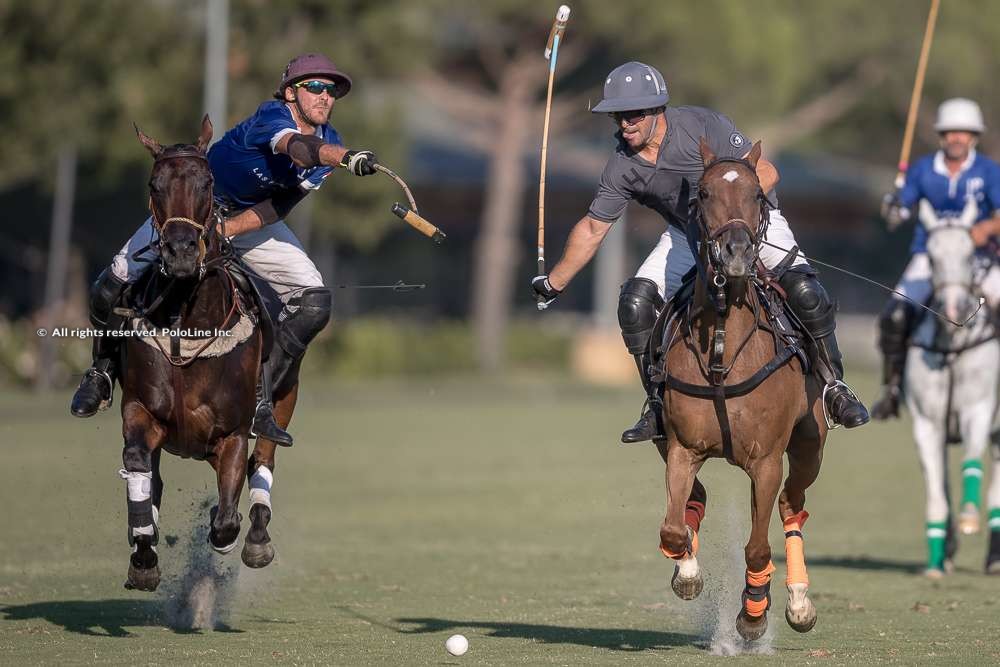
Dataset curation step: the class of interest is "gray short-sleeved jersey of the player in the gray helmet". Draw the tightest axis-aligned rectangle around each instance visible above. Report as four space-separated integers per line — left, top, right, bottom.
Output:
587 107 778 224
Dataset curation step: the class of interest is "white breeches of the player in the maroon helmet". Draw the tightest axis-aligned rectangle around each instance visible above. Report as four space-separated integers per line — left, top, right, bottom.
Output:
111 218 323 303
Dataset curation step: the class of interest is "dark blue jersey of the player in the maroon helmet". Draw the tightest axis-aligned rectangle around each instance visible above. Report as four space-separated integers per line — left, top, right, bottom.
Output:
208 100 341 210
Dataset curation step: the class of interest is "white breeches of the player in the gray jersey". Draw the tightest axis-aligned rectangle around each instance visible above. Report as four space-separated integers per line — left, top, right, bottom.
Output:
635 209 808 299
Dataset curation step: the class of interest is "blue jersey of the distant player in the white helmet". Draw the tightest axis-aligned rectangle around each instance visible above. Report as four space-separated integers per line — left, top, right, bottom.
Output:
899 150 1000 253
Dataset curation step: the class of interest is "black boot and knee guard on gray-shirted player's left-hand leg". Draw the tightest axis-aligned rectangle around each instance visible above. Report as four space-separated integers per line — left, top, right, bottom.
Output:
618 278 663 444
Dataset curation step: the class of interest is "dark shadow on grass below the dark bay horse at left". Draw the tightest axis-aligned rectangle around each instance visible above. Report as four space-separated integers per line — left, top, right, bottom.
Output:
0 599 243 637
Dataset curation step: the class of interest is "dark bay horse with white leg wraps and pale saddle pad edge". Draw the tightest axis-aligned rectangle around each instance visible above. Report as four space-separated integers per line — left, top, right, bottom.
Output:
120 116 274 591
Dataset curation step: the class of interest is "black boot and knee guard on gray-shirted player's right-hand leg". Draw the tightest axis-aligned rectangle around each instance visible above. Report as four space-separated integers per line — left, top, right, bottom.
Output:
779 266 869 428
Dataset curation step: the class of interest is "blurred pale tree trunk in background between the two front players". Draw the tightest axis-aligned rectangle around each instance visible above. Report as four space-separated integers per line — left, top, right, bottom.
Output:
472 67 536 372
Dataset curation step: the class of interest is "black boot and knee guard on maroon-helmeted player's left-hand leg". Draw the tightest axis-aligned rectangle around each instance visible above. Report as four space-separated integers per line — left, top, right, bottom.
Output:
69 269 126 417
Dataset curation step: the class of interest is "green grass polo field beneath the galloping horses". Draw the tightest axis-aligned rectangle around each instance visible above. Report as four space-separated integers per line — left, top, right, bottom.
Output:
0 375 1000 665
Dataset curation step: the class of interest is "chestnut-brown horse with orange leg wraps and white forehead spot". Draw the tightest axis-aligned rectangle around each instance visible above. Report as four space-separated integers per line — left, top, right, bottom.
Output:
653 140 827 641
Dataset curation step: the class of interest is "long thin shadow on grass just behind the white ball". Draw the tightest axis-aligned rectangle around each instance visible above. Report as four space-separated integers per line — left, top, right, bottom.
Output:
394 618 700 651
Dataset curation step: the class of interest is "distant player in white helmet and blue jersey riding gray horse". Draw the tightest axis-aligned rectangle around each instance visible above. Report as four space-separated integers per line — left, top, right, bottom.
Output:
871 98 1000 419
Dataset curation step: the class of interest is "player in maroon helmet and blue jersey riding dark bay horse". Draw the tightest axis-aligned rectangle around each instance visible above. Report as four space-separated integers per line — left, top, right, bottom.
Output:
71 53 375 445
